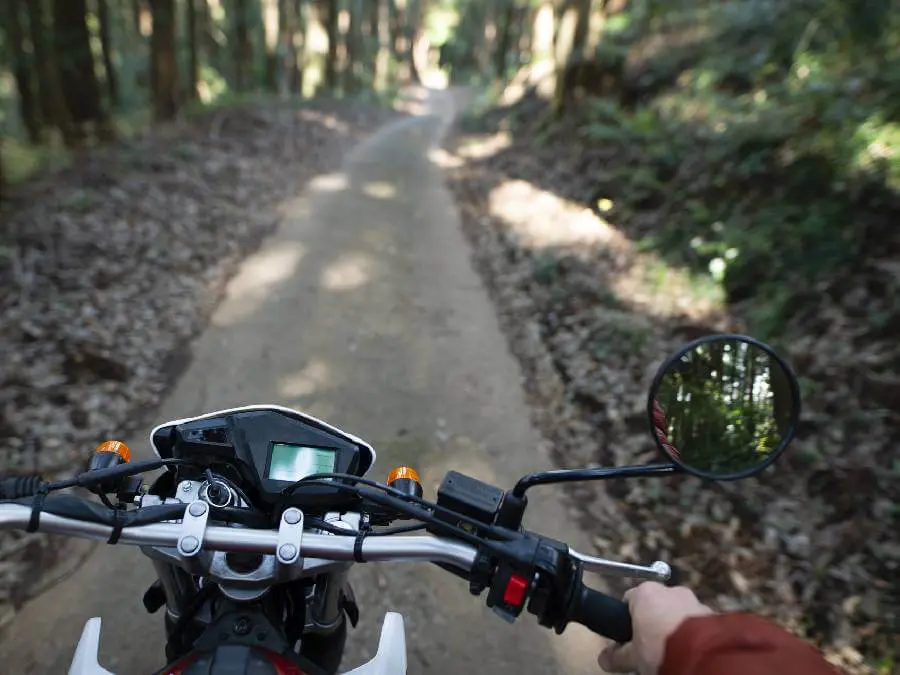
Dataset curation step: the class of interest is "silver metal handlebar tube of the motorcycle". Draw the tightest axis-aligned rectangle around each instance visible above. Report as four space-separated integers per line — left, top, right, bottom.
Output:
0 504 476 570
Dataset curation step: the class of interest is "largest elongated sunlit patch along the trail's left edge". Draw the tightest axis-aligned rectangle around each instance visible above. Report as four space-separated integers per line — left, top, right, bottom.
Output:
215 242 306 326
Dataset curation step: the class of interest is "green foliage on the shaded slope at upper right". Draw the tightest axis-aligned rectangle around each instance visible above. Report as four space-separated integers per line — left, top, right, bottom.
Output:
564 0 900 334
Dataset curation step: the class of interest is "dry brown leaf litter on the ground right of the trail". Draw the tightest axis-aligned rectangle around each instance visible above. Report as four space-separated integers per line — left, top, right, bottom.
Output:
451 119 900 673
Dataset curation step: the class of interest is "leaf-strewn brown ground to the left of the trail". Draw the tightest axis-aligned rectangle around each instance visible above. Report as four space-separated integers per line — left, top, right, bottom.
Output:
0 99 397 626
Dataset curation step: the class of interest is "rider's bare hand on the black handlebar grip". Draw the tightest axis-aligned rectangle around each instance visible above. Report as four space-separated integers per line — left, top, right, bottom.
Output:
599 581 713 675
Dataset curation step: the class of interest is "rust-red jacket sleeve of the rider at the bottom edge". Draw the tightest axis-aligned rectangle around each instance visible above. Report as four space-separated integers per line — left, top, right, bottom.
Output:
659 614 839 675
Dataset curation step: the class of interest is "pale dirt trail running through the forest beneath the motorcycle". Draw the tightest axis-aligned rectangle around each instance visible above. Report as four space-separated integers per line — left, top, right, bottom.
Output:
0 92 599 675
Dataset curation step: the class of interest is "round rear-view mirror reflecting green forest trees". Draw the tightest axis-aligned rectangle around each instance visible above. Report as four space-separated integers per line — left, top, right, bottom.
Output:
648 336 800 480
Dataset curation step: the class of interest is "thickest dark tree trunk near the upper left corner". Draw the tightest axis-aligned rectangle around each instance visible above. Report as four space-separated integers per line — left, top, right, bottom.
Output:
53 0 107 132
